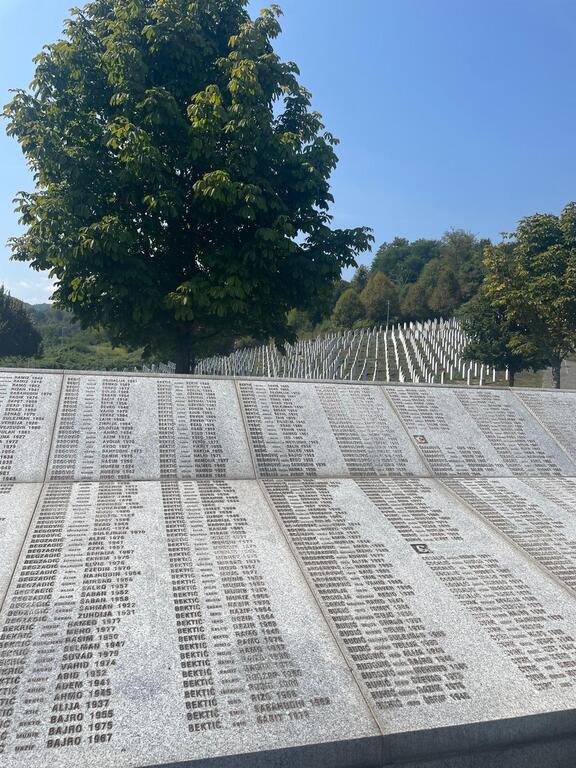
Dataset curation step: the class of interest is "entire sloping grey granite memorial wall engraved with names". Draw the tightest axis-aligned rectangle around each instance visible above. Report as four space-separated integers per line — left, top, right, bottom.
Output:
0 371 576 768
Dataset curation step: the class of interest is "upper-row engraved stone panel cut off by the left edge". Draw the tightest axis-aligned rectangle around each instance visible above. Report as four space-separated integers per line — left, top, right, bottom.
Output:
0 372 62 483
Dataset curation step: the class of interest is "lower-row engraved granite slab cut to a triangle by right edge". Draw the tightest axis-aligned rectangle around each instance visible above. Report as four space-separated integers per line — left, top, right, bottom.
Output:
445 477 576 590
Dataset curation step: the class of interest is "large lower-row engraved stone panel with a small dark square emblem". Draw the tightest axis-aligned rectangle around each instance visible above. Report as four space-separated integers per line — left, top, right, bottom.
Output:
265 478 576 759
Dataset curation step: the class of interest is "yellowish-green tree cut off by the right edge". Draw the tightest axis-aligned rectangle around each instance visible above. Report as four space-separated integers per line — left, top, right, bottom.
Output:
484 203 576 388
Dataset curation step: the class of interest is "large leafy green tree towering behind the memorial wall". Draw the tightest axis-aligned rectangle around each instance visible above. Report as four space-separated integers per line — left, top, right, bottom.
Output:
6 0 371 371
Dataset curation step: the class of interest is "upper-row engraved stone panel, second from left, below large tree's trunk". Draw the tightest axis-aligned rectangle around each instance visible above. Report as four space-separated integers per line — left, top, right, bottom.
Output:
48 375 254 481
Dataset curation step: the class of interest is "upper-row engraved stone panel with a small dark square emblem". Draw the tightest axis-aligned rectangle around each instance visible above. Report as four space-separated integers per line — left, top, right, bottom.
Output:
386 387 576 477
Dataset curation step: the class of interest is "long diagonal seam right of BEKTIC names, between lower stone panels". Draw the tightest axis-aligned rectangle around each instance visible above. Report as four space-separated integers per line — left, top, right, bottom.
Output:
256 478 386 740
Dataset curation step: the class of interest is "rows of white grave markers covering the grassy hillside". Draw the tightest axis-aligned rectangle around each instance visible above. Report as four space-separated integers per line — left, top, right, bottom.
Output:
189 318 508 386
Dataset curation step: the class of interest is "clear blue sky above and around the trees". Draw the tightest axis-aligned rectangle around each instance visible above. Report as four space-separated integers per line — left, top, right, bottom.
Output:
0 0 576 302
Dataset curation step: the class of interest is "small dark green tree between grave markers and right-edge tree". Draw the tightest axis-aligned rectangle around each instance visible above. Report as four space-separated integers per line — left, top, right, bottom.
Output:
458 289 545 387
